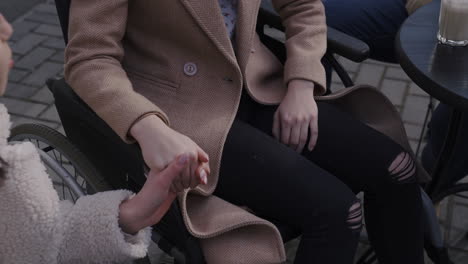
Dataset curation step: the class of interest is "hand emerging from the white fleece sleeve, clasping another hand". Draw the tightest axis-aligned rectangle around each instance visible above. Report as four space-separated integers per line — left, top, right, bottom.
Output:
119 154 189 234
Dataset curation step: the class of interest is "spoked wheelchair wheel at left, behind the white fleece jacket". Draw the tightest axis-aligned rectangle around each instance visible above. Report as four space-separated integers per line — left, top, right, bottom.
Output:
9 124 111 202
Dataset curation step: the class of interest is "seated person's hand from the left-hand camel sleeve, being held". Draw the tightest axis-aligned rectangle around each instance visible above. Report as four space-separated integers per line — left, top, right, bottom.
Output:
130 115 210 193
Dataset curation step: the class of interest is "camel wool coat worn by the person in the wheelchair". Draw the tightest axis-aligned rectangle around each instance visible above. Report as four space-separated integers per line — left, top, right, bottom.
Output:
65 0 428 264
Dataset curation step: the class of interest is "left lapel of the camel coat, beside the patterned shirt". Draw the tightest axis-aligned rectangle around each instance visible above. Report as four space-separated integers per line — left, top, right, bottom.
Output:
180 0 236 63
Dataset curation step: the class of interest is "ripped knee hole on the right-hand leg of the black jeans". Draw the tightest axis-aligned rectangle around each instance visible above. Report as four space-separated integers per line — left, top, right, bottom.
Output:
388 152 416 183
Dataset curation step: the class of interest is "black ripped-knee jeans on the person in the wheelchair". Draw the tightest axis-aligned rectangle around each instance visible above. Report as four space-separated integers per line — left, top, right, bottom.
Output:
215 89 423 264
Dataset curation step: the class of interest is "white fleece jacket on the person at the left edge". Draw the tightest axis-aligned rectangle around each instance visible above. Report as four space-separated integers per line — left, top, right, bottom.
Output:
0 104 151 264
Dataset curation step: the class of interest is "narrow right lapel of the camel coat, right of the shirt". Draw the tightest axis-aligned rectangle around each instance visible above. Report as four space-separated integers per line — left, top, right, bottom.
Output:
236 0 261 73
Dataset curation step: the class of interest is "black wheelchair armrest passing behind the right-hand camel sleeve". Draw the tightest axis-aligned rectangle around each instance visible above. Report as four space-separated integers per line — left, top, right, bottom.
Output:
258 0 370 62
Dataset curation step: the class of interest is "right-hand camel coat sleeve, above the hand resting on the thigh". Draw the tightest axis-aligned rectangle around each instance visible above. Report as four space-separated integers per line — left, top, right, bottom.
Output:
272 0 327 95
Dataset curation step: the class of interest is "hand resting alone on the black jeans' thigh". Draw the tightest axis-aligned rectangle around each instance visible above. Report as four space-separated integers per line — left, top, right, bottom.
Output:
273 80 318 153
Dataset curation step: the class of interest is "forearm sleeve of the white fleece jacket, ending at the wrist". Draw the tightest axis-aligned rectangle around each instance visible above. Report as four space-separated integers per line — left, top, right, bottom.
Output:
58 190 151 263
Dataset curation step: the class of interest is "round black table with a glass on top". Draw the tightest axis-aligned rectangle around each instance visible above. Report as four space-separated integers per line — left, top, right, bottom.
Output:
396 0 468 199
